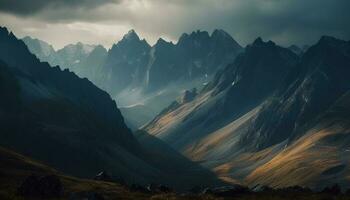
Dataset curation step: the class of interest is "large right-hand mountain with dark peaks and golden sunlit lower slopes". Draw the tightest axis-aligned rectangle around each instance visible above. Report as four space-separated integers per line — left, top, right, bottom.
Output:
143 36 350 189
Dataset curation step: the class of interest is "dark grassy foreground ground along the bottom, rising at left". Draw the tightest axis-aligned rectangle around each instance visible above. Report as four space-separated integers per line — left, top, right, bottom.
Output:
0 145 350 200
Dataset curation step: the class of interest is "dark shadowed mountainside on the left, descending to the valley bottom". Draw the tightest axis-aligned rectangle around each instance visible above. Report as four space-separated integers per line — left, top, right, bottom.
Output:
0 27 221 190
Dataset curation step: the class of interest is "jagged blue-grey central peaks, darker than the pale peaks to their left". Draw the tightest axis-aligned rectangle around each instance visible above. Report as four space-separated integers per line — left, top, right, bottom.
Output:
102 30 242 94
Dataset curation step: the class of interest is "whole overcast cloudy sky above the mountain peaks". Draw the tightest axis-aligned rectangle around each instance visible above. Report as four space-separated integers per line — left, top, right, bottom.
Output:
0 0 350 49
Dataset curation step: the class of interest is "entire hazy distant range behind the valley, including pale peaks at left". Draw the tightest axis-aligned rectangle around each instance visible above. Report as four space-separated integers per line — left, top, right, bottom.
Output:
23 30 243 127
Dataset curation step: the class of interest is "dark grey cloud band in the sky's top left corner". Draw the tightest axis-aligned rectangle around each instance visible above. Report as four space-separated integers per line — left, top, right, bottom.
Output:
0 0 119 16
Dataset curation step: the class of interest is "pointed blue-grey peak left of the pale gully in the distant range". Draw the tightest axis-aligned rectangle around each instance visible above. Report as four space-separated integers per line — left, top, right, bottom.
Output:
100 30 151 96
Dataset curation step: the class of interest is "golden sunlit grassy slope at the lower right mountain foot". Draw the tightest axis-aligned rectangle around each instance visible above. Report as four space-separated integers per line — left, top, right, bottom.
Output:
245 124 348 187
